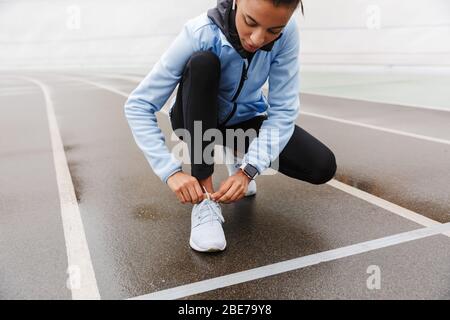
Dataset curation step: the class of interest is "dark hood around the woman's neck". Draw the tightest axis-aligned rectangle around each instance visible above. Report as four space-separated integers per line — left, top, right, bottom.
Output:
208 0 282 58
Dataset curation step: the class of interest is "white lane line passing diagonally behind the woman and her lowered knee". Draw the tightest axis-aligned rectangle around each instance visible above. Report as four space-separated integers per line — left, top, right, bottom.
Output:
65 78 450 230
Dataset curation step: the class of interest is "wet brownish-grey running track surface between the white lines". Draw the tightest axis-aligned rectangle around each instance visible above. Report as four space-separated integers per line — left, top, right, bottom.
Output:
0 73 450 299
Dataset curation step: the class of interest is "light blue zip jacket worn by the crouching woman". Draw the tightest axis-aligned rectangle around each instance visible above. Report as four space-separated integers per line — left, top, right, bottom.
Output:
125 13 300 182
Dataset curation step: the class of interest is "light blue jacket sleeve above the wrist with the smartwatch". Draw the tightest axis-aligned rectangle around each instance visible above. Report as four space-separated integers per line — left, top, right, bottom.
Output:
243 17 300 174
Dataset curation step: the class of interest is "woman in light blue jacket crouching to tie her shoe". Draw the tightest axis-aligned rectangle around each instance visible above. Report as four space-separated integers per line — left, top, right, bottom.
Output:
125 0 336 252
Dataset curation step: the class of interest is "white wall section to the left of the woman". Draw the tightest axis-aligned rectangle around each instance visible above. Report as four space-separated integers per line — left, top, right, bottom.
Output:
0 0 215 68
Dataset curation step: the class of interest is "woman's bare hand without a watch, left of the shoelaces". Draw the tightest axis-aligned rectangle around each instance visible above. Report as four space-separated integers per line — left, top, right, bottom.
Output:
167 171 206 204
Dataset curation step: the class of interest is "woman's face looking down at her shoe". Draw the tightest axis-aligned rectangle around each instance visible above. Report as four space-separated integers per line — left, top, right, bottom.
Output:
236 0 295 52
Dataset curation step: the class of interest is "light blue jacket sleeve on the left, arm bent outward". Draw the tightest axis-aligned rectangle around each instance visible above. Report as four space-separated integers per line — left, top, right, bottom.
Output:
124 23 200 183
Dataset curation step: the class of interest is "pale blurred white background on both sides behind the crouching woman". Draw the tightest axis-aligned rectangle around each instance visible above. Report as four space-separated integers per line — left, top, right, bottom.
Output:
0 0 450 109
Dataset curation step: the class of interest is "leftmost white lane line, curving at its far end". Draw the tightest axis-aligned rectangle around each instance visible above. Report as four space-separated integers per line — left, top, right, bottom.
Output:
17 77 100 300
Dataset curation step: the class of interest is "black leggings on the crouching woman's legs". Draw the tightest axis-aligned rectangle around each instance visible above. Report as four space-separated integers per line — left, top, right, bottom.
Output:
171 51 336 184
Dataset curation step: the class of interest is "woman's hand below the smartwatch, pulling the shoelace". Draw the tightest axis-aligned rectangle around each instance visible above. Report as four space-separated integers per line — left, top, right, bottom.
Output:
211 170 251 203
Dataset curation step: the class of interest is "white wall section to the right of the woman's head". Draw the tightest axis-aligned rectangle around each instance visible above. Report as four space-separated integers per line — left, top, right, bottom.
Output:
300 0 450 71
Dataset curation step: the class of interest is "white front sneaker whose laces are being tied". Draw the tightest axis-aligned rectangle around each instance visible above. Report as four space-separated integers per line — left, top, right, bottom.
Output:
189 194 227 252
